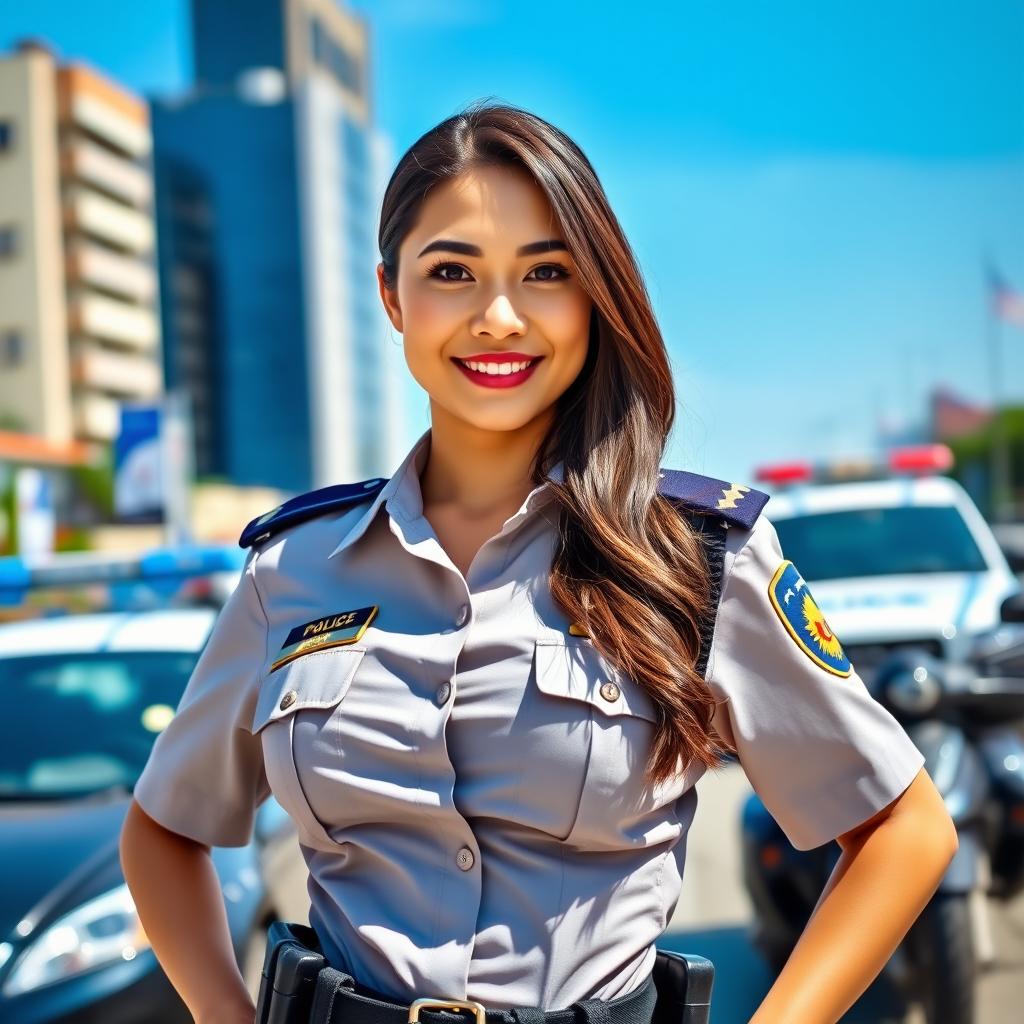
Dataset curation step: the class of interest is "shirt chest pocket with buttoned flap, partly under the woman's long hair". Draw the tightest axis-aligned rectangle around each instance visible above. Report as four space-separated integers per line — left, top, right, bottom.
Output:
525 632 673 850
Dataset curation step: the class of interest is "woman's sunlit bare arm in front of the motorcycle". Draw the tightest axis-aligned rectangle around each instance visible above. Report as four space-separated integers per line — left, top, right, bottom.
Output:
751 768 958 1024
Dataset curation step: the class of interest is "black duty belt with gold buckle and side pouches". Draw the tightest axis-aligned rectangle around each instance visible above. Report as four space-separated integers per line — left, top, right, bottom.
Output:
255 921 715 1024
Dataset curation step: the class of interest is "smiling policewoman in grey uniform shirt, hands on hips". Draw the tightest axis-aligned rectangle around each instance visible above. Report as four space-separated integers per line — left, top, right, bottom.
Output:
122 104 956 1024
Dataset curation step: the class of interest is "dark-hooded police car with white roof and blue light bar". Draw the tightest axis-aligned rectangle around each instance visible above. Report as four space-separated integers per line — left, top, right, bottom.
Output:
0 548 308 1024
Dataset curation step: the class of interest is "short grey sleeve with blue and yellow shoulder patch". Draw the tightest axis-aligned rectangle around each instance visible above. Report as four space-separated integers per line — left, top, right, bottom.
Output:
707 516 925 850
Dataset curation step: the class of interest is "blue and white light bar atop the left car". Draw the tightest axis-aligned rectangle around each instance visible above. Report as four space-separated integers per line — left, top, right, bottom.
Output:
0 546 246 604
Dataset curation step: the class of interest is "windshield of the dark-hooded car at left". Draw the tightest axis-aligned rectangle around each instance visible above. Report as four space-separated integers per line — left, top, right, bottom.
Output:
0 651 198 801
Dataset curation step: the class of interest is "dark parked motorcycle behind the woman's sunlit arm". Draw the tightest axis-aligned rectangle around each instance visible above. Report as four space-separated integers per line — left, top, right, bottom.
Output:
741 594 1024 1024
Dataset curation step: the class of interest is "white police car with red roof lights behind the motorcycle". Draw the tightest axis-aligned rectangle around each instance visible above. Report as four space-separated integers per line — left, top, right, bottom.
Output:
757 444 1020 679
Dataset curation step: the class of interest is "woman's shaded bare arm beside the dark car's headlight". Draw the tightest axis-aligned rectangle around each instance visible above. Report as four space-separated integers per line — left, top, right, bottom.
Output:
120 800 256 1024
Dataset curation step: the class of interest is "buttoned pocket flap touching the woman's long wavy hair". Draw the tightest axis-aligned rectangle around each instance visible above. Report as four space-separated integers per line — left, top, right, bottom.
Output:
534 637 657 722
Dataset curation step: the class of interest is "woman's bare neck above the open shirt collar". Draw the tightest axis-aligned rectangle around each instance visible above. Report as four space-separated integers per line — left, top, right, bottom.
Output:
420 402 551 518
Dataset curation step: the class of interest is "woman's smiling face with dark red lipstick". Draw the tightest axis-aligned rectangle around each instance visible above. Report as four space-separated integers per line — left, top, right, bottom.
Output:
377 167 591 430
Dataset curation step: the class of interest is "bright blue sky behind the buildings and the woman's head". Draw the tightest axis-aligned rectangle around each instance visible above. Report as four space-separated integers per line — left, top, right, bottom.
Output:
0 0 1024 479
